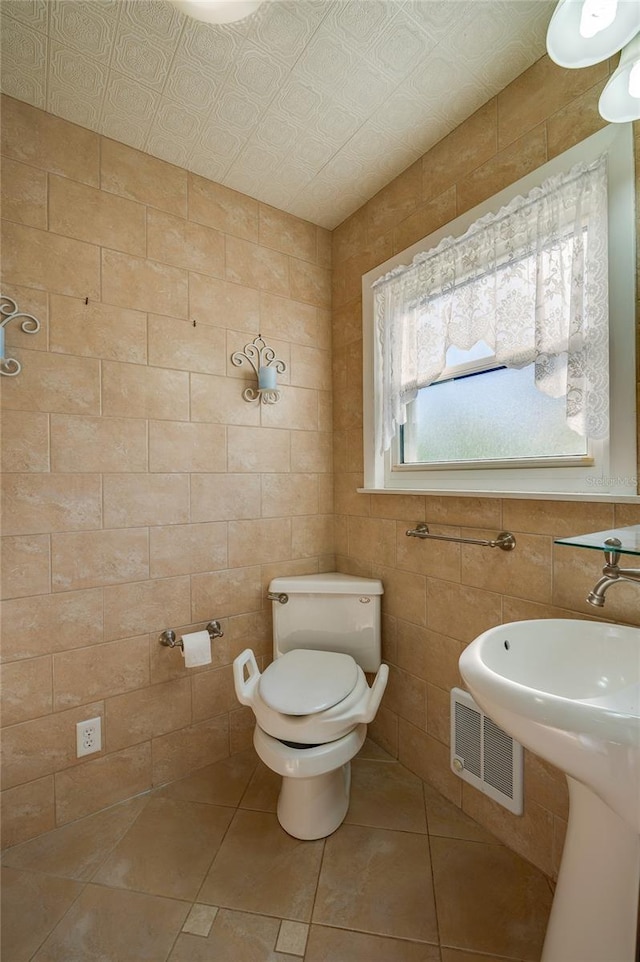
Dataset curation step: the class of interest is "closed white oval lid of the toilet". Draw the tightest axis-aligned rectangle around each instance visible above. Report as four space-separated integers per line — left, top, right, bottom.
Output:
259 648 358 715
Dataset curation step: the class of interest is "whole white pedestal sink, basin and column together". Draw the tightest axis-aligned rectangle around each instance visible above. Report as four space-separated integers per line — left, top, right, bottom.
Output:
460 619 640 962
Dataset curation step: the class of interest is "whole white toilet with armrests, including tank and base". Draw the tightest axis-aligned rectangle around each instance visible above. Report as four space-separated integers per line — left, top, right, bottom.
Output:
233 572 389 839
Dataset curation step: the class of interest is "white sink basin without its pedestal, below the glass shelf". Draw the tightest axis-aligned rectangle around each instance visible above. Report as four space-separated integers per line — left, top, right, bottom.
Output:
460 619 640 832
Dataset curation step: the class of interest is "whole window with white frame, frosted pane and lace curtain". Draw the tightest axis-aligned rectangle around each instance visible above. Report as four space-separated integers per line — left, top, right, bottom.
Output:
363 125 637 497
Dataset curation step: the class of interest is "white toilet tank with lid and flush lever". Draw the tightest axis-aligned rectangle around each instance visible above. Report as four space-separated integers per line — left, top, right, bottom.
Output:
269 572 384 671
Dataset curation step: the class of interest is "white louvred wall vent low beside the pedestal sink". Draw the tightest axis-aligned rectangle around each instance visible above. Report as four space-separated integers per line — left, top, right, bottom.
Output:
451 688 523 815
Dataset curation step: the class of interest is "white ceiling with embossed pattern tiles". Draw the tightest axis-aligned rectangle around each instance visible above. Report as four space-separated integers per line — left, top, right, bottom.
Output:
0 0 555 228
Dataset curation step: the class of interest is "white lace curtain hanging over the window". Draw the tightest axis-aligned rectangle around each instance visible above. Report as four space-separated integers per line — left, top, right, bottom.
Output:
373 156 609 451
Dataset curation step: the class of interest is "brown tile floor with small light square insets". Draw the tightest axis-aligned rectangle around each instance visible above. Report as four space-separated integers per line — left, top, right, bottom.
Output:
0 742 551 962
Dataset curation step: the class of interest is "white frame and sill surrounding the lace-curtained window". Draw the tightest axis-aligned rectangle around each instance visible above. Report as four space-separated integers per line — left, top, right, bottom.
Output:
359 124 640 502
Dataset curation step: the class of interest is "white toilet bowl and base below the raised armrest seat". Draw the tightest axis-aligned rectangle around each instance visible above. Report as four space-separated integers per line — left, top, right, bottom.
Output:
253 725 367 839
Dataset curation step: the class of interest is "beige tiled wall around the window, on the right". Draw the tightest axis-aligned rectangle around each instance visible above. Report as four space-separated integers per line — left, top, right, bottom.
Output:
333 57 640 874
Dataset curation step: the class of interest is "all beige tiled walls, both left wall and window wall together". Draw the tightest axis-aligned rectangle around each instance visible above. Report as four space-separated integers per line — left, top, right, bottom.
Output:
2 50 640 873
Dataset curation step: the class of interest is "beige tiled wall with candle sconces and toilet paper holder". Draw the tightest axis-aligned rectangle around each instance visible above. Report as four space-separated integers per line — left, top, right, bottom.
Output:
1 98 334 846
